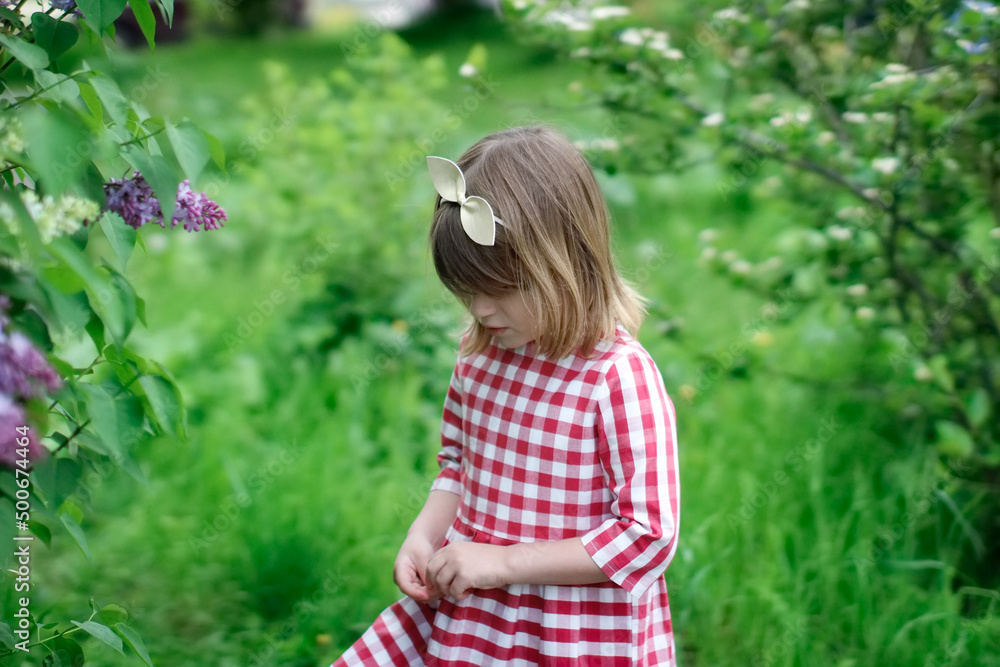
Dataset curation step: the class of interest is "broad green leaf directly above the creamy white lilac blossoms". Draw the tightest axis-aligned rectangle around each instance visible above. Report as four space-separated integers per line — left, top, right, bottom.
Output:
21 107 93 196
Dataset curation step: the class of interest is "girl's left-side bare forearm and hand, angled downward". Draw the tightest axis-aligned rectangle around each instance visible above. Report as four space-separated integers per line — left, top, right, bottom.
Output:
392 490 458 602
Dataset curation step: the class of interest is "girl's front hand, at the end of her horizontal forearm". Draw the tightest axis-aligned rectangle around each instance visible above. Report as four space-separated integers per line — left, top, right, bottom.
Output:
426 542 509 600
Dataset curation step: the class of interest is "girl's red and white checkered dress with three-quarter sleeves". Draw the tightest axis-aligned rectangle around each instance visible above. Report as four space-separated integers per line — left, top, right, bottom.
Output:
334 328 680 667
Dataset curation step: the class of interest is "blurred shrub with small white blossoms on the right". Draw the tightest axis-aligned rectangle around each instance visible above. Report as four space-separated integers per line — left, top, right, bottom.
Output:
505 0 1000 585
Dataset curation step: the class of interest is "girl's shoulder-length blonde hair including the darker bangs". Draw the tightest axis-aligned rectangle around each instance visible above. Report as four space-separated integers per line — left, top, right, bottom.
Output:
430 126 646 358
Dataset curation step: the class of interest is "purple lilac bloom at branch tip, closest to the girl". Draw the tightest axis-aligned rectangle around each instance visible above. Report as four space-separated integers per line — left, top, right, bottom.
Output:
104 171 229 232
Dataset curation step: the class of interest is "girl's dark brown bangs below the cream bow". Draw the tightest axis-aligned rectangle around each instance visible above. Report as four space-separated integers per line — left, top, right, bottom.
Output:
430 202 520 297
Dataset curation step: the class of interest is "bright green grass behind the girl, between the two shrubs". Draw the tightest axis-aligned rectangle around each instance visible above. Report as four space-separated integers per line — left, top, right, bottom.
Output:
25 11 1000 667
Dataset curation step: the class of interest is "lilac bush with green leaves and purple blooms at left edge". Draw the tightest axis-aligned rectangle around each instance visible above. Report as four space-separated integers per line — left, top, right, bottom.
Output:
0 0 226 665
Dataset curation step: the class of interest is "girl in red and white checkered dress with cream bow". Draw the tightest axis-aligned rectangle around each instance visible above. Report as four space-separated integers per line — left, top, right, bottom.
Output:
334 127 680 667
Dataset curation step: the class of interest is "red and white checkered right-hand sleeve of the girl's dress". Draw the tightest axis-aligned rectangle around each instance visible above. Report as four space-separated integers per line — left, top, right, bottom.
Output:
581 351 680 598
